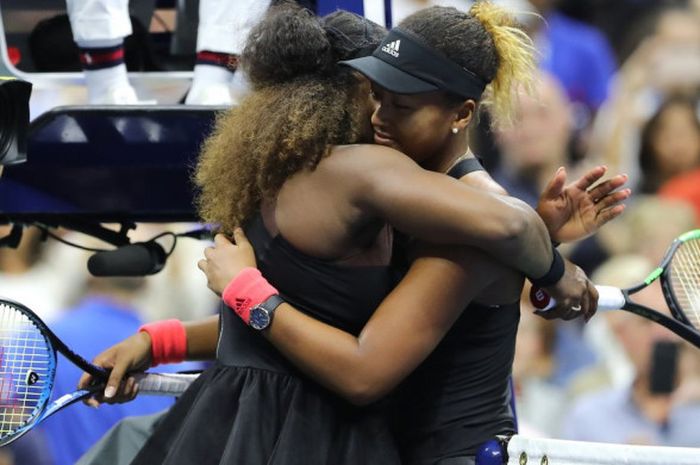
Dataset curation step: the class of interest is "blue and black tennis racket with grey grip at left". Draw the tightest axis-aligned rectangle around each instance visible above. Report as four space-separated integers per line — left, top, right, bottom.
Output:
0 299 197 447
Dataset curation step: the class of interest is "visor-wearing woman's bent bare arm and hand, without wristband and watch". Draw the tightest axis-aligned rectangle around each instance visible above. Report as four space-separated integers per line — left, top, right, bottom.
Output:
198 231 506 405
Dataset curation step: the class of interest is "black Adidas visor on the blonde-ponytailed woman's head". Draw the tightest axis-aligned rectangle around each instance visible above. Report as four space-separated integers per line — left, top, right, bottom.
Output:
340 28 486 99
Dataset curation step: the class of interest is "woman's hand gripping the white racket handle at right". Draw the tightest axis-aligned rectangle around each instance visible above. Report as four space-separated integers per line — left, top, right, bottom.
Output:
535 259 598 321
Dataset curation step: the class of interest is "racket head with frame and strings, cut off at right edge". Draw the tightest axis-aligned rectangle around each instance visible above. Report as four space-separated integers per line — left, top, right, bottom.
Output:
660 229 700 330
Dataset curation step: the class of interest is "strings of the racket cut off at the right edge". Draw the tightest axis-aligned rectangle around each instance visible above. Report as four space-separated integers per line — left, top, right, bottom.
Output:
670 239 700 329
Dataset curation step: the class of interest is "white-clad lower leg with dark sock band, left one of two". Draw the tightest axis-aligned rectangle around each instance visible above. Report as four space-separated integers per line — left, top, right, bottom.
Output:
66 0 138 105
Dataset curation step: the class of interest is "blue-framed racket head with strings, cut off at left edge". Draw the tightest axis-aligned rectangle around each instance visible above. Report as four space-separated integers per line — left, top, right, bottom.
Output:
0 298 56 447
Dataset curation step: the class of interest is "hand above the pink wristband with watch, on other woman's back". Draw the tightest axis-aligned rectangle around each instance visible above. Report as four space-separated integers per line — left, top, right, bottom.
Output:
197 228 256 295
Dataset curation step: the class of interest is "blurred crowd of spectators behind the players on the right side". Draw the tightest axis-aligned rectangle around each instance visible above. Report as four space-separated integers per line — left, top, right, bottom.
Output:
470 0 700 447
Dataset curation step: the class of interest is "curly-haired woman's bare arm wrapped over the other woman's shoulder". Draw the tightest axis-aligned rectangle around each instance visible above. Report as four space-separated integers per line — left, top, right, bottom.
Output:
324 146 552 278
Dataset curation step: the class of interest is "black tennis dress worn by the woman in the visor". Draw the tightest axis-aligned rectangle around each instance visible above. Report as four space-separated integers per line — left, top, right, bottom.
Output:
392 158 520 465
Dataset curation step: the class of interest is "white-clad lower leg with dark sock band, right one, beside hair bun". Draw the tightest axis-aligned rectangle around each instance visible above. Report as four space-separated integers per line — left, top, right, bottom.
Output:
185 0 270 105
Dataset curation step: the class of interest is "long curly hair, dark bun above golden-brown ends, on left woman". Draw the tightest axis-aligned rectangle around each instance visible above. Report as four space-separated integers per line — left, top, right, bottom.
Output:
194 4 383 232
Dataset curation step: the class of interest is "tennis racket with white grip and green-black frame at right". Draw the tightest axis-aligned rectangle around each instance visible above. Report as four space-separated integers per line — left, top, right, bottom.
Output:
530 229 700 348
